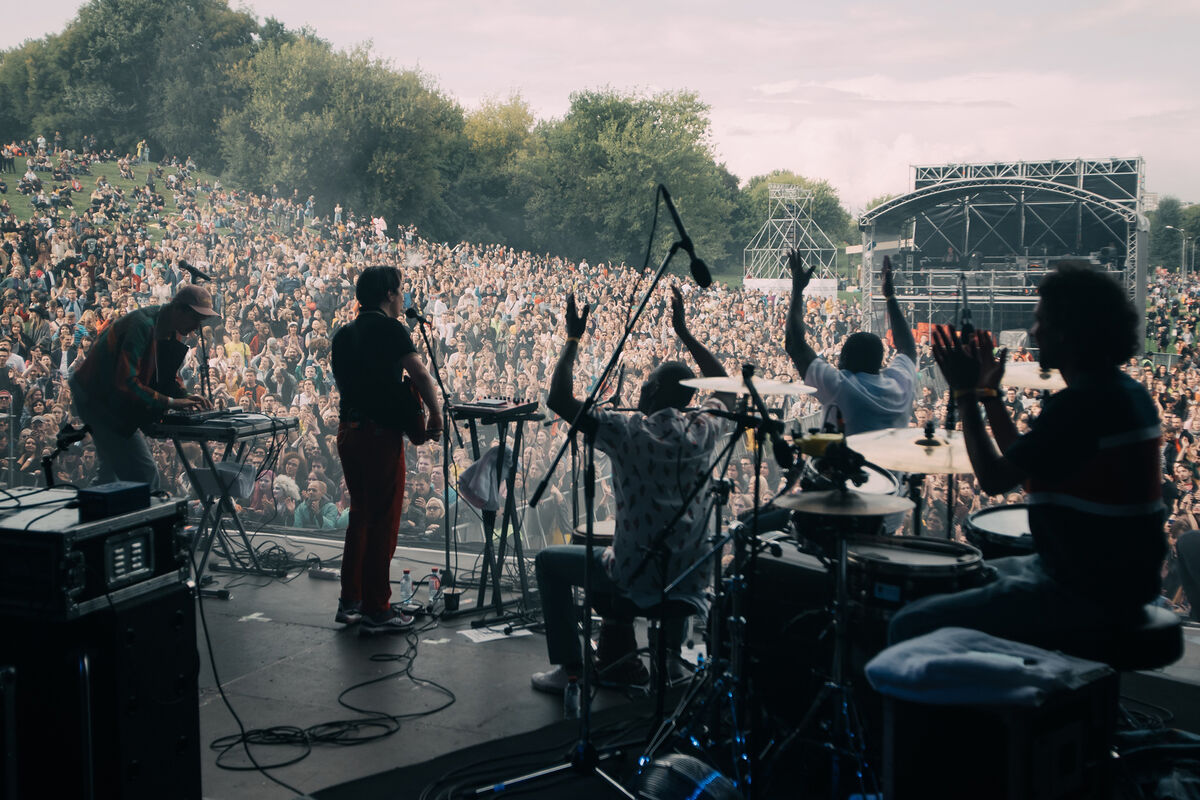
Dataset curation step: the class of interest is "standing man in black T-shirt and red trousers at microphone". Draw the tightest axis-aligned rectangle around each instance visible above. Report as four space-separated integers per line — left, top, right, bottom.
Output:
332 266 442 633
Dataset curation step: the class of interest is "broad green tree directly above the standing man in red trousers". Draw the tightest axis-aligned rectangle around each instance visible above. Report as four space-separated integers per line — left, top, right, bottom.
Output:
221 35 463 237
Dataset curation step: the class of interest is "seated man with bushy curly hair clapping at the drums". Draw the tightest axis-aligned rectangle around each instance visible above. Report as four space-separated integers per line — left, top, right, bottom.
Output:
888 263 1166 649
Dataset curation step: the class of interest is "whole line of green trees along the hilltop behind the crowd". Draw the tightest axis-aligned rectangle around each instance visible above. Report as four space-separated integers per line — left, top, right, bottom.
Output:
0 0 858 275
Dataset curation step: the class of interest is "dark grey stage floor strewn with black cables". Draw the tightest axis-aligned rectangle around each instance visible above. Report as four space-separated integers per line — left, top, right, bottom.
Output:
199 536 1200 800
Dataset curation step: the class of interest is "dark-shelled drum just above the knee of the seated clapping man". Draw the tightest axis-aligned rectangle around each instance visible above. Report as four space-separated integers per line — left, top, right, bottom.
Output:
846 536 989 619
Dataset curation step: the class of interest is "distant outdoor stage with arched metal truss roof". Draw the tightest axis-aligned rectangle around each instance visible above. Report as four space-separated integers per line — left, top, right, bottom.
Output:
859 157 1148 345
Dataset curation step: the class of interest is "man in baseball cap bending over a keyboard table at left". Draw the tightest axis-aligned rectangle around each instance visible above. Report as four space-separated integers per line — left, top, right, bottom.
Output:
70 284 220 491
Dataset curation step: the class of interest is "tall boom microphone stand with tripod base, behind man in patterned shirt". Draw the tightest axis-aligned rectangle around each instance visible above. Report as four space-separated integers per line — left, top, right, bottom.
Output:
475 241 683 800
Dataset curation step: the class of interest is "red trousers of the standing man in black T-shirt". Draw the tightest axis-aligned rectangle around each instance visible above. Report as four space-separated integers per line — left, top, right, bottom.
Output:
337 422 404 615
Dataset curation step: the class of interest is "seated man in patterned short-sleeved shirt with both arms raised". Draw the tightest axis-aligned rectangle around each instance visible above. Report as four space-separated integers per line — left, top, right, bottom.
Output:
532 289 733 692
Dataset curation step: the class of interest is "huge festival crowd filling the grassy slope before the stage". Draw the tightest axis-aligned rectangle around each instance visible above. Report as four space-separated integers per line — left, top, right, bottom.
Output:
0 137 1200 603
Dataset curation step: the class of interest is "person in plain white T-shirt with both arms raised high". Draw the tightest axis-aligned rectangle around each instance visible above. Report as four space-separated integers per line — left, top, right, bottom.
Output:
785 251 917 435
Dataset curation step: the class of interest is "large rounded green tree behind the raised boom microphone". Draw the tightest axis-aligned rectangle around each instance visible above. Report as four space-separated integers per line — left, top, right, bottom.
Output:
523 90 740 271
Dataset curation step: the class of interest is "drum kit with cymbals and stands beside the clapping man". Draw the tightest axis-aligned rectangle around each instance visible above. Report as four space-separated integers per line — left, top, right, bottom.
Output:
642 365 1061 798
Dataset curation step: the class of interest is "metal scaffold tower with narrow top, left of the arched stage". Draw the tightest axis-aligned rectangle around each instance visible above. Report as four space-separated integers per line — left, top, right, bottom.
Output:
742 184 838 289
